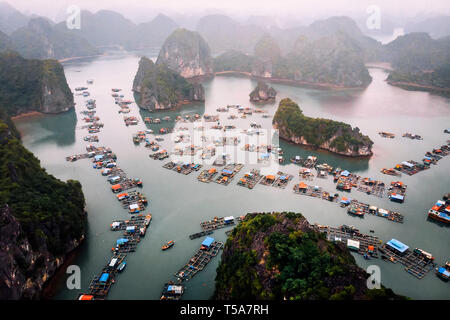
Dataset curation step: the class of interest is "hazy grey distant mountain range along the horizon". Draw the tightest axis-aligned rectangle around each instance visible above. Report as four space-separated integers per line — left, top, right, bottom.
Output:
0 4 450 92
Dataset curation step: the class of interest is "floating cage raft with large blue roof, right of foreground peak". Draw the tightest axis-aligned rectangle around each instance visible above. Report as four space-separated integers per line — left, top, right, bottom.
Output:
379 243 436 279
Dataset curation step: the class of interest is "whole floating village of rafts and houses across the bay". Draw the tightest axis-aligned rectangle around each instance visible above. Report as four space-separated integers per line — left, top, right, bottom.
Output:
66 80 450 300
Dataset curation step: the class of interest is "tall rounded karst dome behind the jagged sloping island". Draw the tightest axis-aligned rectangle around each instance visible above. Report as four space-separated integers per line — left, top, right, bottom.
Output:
156 29 213 78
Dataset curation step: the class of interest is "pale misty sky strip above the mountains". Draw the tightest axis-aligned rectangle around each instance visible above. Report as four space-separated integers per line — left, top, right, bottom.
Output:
6 0 450 21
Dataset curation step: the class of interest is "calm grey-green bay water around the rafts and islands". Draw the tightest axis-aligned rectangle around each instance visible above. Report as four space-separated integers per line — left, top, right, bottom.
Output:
16 55 450 299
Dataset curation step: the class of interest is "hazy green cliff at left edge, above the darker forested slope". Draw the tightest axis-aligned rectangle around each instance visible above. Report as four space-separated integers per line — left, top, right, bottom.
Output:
0 51 74 116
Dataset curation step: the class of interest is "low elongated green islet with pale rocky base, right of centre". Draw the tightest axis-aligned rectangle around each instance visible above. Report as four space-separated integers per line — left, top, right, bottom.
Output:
273 98 373 157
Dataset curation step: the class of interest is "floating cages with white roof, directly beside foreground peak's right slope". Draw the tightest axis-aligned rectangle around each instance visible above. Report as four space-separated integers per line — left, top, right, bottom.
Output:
313 224 382 258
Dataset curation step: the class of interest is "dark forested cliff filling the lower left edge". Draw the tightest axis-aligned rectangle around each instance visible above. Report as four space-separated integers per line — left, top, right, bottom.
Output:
0 115 86 300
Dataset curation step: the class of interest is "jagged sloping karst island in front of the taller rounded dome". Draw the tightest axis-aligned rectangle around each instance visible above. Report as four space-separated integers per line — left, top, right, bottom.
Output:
133 57 205 110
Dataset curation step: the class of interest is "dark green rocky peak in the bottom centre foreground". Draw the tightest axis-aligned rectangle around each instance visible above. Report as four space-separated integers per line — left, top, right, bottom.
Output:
214 212 405 300
